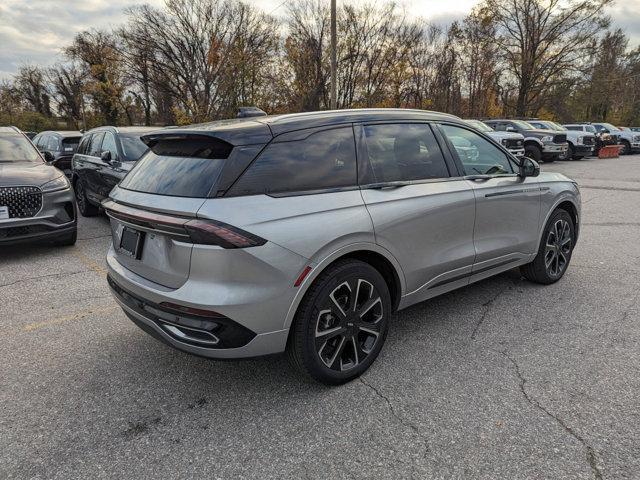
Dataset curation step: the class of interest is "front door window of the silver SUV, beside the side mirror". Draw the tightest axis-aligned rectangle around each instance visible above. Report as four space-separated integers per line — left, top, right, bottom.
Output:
442 125 513 175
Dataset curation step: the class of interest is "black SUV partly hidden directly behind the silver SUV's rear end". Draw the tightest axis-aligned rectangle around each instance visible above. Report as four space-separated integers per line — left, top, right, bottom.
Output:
72 127 158 217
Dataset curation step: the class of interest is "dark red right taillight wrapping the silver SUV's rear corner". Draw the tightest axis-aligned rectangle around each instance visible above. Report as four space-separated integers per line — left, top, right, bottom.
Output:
184 220 267 248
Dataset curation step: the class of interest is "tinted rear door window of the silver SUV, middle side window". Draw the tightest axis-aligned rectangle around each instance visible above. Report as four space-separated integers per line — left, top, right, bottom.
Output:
361 124 449 183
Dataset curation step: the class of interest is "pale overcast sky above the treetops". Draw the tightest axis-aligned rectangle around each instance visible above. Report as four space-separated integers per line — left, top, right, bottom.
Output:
0 0 640 78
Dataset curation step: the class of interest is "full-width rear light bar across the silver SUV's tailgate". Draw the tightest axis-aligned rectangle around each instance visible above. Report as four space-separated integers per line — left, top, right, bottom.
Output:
102 200 267 249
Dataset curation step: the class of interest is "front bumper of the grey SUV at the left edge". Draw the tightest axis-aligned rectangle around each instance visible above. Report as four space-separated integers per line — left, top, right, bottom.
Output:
0 188 78 245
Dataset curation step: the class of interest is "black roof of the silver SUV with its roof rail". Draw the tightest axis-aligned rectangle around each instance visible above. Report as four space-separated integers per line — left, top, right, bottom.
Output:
143 108 463 145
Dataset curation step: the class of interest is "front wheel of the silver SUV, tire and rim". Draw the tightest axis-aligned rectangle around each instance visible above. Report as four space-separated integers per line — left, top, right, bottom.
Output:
520 209 576 285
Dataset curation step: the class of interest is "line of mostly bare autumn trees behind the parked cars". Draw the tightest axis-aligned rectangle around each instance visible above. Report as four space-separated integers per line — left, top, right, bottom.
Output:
0 0 640 130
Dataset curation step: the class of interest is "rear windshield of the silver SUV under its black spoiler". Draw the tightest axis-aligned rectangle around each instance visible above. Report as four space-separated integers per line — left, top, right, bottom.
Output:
120 138 233 198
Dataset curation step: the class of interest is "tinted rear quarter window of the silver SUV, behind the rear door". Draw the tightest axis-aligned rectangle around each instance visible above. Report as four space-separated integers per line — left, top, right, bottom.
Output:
228 127 357 196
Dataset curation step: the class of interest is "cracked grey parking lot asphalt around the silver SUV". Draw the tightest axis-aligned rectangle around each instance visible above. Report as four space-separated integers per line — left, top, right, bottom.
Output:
0 155 640 480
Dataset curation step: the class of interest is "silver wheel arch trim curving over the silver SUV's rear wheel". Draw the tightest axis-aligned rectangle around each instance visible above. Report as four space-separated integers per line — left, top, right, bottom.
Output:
284 243 405 329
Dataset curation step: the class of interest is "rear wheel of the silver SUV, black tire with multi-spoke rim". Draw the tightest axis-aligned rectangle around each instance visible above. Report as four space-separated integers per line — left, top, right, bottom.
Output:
287 259 391 385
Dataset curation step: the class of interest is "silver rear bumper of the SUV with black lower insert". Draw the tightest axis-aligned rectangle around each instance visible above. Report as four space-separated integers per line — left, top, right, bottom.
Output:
107 243 305 359
